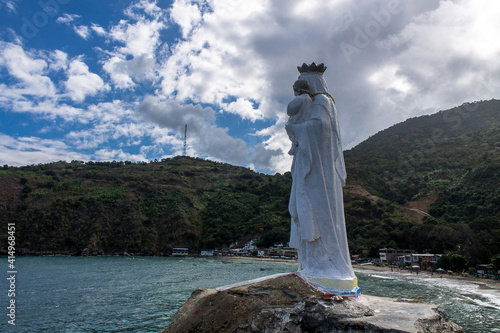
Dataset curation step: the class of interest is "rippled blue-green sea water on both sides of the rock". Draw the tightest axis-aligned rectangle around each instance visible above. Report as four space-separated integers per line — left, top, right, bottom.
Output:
0 256 500 333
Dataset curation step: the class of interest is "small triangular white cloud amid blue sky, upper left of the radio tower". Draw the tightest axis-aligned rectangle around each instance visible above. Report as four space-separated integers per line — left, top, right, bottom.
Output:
65 58 109 102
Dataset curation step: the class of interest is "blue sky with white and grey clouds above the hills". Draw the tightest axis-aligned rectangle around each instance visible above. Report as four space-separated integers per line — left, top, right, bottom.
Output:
0 0 500 173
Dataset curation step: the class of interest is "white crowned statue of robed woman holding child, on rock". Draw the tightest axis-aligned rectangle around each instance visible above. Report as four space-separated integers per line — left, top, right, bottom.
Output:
286 63 359 297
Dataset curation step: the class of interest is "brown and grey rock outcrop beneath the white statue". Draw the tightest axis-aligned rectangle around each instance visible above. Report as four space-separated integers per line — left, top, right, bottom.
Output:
163 273 463 333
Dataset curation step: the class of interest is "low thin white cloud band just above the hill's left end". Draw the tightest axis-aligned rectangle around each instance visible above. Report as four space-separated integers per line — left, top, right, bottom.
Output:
0 133 88 166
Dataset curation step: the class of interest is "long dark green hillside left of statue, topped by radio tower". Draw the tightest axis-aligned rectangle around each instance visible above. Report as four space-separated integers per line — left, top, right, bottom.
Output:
0 157 291 255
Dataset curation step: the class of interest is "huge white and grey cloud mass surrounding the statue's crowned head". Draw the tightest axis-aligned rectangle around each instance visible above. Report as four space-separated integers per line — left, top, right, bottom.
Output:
92 0 497 171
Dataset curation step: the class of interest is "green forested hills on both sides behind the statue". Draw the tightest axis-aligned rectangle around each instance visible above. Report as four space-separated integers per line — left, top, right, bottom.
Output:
0 100 500 265
